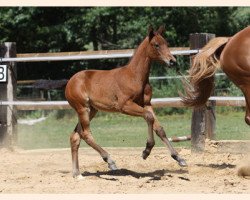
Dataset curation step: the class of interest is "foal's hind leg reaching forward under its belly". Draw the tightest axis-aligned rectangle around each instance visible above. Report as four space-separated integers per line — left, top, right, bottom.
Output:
77 107 117 170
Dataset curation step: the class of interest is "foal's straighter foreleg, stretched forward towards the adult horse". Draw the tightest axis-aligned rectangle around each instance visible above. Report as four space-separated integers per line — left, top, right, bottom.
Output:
143 105 187 166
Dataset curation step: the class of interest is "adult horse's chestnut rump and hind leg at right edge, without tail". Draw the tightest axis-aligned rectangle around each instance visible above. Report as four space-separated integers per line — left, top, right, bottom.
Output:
220 27 250 125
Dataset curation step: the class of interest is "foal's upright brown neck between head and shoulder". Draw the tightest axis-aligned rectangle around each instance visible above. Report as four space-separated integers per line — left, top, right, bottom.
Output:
128 38 151 82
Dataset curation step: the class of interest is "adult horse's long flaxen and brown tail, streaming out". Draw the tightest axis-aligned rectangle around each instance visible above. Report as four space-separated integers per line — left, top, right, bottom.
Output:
181 37 229 107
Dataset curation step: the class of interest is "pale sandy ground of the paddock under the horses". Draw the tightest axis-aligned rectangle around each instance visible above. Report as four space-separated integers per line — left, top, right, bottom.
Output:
0 141 250 194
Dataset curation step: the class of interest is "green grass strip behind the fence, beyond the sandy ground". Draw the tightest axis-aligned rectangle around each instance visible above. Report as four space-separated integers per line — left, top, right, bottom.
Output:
18 111 250 149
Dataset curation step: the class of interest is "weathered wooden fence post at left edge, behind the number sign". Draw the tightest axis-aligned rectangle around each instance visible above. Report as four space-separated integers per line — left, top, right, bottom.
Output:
0 42 17 148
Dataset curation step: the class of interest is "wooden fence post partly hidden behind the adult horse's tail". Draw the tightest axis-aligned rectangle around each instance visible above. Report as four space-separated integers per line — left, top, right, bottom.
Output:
189 33 215 152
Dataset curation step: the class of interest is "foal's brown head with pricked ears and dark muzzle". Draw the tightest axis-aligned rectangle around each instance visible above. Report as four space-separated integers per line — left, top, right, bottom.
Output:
147 26 176 66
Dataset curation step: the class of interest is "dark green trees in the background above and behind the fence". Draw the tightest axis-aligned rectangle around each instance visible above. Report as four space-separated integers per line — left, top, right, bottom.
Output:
0 7 250 79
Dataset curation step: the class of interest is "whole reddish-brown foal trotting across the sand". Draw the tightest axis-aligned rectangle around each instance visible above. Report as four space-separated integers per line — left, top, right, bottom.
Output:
65 27 186 178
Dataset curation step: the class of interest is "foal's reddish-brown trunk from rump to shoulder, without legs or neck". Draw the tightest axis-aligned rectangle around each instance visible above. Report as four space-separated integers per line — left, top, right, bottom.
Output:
65 66 133 112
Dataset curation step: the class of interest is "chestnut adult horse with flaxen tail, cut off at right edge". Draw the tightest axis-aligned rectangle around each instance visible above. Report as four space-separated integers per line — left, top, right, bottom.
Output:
182 27 250 175
